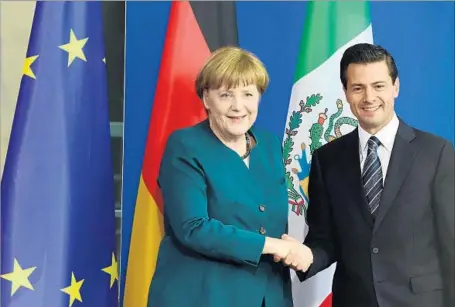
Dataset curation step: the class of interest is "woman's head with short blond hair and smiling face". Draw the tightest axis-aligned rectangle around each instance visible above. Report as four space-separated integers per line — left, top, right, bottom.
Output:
195 47 269 142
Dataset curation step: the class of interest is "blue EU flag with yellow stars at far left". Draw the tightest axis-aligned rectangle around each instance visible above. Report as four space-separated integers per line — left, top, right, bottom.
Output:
0 1 118 307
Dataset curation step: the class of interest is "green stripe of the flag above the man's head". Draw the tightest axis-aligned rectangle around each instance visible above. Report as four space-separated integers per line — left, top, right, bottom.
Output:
294 1 370 82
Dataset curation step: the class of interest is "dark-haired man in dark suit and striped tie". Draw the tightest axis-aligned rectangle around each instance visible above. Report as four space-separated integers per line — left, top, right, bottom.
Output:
283 44 455 307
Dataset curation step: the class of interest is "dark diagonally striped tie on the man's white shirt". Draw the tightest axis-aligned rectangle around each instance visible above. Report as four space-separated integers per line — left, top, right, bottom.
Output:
362 136 383 218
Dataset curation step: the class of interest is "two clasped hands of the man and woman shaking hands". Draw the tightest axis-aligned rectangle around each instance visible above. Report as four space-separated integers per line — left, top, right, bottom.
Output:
263 234 313 272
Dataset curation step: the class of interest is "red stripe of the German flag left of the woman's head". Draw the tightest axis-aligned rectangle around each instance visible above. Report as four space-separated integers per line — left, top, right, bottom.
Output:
142 1 210 207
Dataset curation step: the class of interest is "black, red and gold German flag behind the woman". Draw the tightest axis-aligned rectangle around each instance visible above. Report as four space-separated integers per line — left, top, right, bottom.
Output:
123 1 238 307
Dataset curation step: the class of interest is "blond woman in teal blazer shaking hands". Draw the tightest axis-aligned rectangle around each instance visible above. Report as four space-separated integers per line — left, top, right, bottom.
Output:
148 47 308 307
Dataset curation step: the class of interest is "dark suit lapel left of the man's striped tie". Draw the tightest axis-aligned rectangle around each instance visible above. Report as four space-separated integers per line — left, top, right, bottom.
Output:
340 128 373 228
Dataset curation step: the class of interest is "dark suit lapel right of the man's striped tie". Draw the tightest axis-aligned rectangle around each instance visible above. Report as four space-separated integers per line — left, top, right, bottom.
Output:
373 120 417 233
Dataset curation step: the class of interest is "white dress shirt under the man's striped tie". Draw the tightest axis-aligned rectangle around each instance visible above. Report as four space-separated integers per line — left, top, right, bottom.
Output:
358 113 400 182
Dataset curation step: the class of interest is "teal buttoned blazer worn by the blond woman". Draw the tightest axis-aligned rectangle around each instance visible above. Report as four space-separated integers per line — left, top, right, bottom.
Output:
148 120 293 307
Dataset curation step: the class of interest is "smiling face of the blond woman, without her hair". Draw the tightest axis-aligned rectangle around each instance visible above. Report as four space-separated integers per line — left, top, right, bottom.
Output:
203 84 261 138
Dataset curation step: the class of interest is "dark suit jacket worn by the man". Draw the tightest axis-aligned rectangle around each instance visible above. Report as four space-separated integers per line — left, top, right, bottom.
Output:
299 120 455 307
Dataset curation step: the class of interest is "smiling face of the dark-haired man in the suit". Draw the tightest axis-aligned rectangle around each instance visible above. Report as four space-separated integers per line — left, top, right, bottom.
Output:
345 61 400 134
